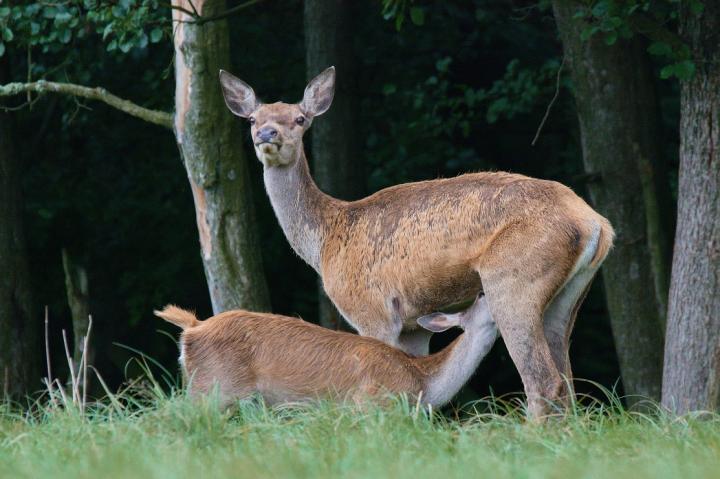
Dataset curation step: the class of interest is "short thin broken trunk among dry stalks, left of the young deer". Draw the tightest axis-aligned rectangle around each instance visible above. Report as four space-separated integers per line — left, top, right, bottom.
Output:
62 248 95 387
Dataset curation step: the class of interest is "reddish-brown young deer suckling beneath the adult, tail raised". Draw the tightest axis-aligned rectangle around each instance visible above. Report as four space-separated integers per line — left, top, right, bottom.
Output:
155 298 497 406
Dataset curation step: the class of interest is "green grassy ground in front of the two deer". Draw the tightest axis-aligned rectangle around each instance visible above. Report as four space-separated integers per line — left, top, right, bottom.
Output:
0 386 720 479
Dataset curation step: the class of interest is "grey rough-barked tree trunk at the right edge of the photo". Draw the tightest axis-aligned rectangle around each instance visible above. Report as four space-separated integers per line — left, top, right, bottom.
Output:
662 0 720 413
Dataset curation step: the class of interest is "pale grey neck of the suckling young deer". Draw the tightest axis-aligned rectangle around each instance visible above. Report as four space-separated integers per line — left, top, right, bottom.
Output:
415 323 497 406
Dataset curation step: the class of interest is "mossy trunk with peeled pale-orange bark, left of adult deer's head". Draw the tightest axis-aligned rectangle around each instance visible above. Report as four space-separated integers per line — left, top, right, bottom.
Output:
172 0 270 313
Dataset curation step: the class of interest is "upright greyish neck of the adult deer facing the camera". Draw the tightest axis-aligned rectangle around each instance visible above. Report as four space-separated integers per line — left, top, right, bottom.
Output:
264 149 343 272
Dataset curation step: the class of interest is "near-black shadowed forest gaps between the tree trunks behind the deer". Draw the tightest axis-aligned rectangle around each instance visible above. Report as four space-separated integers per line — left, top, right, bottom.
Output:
2 0 716 412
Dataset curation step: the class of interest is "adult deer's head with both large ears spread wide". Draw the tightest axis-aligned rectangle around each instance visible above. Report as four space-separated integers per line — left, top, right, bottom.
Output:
220 67 335 168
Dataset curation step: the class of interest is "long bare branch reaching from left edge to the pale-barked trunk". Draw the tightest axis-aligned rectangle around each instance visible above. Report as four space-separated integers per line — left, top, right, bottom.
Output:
0 80 173 129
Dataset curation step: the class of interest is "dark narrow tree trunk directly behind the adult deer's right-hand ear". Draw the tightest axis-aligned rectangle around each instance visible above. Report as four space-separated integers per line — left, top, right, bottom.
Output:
305 0 365 329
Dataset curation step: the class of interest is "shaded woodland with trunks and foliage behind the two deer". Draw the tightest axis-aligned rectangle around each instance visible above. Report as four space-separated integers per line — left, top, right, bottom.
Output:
0 0 720 411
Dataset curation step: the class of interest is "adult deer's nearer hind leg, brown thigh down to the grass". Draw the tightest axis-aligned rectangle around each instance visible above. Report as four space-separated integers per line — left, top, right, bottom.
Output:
476 224 577 418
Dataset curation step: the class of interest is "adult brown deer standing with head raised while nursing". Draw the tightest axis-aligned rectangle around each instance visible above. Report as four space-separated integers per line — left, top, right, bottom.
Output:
220 67 614 417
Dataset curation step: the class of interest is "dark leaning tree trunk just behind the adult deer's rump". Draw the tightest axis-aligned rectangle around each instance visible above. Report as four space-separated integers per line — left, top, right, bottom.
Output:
553 0 667 404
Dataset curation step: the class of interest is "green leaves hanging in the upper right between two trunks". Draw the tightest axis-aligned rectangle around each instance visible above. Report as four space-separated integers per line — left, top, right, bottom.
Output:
576 0 703 80
